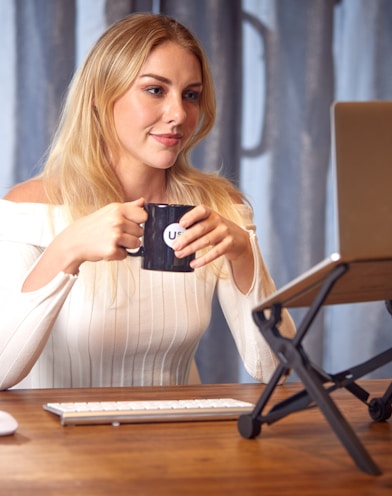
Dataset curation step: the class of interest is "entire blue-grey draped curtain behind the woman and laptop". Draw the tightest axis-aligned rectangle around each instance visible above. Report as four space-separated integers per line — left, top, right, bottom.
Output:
0 0 392 383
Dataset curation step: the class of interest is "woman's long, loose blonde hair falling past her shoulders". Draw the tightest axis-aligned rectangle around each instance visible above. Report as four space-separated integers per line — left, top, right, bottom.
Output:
42 14 248 222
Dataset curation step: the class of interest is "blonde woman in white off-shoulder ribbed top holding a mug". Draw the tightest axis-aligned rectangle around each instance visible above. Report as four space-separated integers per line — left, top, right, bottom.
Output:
0 14 294 389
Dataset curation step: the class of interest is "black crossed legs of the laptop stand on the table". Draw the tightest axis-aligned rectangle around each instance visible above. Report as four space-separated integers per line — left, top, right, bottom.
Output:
238 264 386 475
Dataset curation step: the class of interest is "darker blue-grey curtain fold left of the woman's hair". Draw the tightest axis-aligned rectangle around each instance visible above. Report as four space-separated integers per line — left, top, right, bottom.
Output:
13 0 76 182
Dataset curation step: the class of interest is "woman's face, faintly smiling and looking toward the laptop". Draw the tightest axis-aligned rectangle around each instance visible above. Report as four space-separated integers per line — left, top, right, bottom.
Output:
114 42 202 172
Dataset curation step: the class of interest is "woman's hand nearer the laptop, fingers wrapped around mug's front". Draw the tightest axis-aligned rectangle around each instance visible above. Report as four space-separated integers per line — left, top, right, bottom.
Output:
173 205 252 268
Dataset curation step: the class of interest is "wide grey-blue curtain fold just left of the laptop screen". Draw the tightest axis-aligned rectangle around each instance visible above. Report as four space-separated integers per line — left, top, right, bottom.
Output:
266 0 334 363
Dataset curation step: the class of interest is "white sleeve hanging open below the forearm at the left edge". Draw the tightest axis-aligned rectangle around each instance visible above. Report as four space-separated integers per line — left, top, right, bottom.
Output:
0 241 76 389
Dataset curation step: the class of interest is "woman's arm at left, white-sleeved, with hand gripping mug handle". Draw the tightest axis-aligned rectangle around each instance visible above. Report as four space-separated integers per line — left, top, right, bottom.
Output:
0 180 146 389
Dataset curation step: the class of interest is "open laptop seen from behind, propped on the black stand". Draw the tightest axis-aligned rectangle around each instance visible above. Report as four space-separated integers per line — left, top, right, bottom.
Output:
254 101 392 312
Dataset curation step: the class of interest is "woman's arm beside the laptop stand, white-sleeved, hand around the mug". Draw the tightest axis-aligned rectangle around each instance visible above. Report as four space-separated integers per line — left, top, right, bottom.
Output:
173 205 295 382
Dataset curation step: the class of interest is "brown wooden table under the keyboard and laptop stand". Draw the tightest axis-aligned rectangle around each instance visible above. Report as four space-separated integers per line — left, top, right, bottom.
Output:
0 380 392 496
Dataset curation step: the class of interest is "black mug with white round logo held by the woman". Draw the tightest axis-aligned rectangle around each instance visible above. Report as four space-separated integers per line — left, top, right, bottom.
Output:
128 203 195 272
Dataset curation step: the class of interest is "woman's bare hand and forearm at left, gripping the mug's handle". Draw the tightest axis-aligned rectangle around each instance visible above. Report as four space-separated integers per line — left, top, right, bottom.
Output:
22 198 147 292
